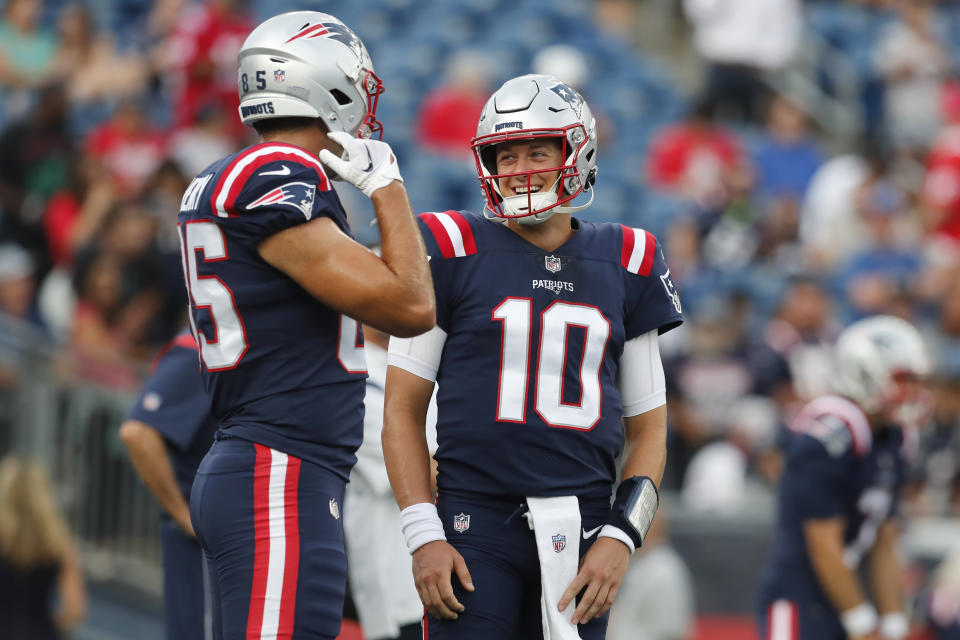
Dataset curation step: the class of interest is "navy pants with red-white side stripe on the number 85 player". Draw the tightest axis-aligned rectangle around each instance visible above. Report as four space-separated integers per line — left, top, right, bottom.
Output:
190 438 347 640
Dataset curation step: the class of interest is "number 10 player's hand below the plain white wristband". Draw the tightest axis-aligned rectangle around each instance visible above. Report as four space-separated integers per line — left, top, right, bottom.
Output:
413 540 473 620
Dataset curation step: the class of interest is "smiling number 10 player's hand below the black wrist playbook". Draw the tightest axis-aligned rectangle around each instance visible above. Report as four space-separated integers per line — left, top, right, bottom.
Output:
557 538 630 624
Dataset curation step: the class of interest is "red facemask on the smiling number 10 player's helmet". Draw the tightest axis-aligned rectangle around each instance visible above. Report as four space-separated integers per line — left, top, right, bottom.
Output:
472 123 593 224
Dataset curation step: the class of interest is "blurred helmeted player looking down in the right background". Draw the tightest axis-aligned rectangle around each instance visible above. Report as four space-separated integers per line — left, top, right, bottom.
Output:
759 316 931 640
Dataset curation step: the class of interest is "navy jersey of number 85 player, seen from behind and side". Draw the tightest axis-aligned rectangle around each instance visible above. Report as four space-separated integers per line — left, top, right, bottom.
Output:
178 142 366 479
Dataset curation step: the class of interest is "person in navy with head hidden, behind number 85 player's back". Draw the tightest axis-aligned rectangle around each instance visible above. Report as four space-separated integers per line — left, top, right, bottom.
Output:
120 331 217 640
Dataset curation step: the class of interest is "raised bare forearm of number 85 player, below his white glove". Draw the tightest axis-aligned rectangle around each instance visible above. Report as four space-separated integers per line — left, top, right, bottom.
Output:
371 182 436 330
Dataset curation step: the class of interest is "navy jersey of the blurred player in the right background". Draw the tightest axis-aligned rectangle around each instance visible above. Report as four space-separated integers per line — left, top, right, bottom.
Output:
761 396 913 610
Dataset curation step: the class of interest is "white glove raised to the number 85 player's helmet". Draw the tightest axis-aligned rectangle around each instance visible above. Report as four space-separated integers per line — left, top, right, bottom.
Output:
319 131 403 198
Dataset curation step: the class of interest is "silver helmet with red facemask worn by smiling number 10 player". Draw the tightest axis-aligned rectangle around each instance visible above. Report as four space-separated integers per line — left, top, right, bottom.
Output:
472 74 597 224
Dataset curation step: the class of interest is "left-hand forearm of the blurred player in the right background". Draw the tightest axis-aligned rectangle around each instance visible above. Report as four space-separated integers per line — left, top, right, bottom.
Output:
804 518 866 613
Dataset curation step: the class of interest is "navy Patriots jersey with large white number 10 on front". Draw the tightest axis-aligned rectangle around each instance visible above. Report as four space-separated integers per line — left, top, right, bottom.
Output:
420 211 681 497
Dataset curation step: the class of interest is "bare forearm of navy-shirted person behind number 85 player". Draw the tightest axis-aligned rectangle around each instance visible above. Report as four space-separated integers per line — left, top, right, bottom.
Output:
120 420 190 528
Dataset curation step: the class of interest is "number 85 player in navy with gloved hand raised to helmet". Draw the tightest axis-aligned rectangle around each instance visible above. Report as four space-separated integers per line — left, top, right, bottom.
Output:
179 11 436 640
